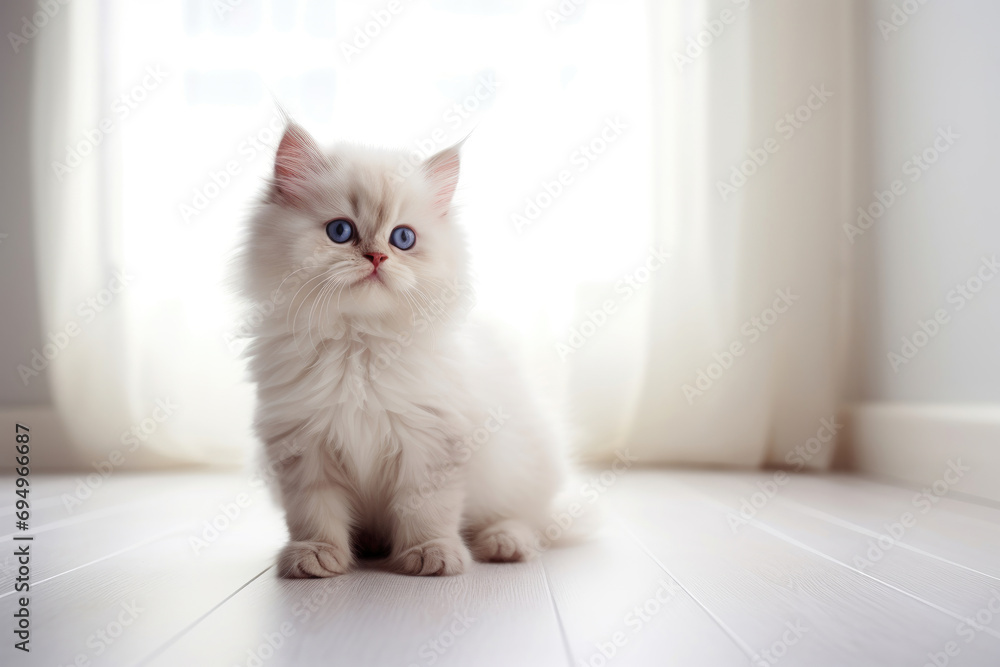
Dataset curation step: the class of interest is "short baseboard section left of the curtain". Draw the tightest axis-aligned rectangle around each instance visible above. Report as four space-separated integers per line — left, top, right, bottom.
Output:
0 405 80 473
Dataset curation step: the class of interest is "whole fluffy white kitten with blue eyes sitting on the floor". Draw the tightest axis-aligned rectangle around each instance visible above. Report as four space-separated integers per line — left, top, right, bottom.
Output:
235 124 567 577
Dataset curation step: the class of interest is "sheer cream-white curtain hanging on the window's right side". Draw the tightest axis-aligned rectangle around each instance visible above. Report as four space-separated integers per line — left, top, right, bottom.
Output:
596 0 854 467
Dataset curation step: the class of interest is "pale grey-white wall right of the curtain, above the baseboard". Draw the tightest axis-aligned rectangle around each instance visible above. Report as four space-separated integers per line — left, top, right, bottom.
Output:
850 0 1000 404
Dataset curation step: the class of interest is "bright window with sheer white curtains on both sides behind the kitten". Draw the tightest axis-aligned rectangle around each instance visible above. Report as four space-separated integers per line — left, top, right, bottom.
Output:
33 0 850 466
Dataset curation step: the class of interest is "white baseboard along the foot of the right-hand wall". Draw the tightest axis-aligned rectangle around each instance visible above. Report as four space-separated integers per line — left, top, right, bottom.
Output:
841 403 1000 501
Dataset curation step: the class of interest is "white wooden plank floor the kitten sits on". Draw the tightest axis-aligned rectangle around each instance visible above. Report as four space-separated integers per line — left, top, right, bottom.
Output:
0 470 1000 667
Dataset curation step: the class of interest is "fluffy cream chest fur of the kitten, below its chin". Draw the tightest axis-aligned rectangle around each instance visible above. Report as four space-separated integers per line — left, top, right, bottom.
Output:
255 329 464 496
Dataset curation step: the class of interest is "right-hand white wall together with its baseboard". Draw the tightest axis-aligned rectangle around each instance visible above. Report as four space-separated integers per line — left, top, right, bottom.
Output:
840 0 1000 501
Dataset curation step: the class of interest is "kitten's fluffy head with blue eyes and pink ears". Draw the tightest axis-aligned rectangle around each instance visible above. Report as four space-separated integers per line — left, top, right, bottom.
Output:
242 123 467 333
